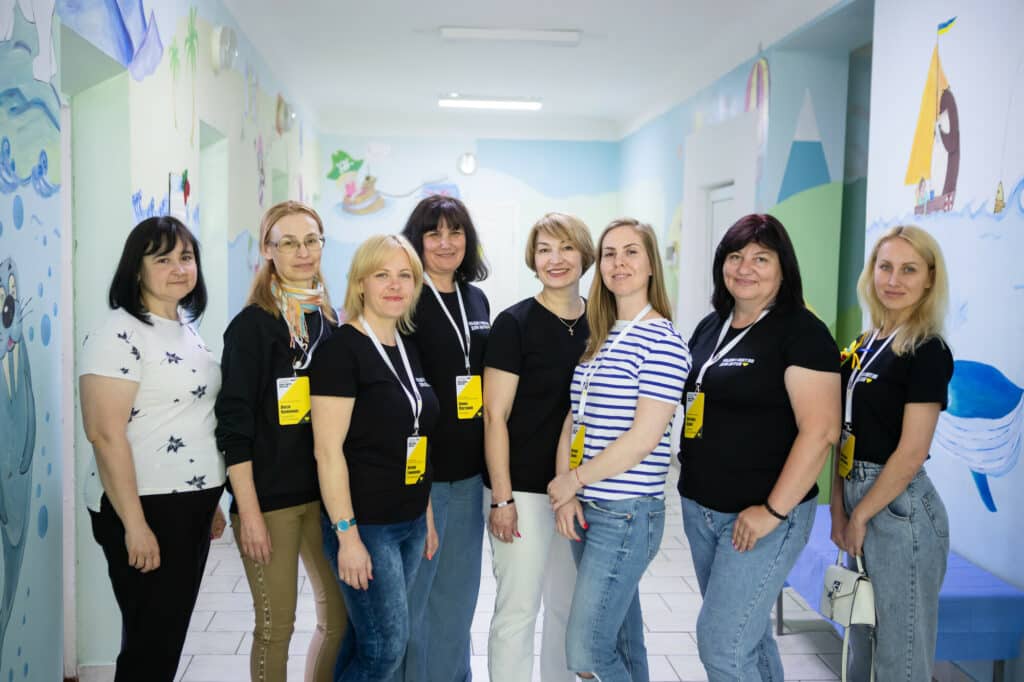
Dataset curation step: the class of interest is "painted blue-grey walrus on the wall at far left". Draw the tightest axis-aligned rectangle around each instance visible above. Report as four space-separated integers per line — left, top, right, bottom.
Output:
0 258 36 647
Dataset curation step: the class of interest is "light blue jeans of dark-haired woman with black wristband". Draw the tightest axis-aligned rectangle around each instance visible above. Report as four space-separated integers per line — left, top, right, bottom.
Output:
682 497 817 682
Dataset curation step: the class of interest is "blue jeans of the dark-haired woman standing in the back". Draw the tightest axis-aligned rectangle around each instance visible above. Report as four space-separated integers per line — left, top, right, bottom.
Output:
395 476 483 682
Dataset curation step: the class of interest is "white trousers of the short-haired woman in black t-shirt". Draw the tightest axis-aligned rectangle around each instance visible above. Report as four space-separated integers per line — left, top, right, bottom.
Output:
483 488 575 682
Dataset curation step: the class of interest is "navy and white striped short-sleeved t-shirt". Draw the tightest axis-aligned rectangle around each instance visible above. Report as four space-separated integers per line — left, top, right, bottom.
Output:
569 318 690 500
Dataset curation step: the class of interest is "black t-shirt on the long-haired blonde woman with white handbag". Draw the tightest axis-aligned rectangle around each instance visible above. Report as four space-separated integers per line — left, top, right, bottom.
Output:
843 337 953 464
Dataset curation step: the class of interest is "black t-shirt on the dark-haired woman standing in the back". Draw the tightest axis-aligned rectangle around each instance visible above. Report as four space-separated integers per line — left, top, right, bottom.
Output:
409 283 490 481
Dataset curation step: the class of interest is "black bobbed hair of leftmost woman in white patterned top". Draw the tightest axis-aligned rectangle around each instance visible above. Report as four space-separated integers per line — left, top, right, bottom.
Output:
106 215 207 325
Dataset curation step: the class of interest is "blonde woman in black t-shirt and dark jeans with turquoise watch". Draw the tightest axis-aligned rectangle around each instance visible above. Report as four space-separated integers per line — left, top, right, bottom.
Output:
310 235 442 682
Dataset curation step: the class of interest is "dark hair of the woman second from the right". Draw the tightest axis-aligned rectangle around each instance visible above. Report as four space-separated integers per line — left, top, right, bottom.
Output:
711 213 804 317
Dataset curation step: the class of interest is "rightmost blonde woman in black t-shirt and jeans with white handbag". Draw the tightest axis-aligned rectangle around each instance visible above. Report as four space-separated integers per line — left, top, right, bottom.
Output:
831 226 953 682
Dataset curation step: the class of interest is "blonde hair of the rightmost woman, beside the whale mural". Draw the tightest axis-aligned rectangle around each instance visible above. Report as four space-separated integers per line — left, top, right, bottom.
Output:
857 225 949 355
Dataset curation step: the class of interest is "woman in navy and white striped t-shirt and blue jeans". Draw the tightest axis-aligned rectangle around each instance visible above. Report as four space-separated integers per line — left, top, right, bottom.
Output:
548 218 690 682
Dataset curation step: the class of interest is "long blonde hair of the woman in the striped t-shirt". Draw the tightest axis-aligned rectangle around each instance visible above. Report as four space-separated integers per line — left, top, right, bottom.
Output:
580 218 672 363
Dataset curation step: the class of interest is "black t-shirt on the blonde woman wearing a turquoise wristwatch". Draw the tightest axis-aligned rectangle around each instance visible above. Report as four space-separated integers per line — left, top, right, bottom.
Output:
309 325 438 525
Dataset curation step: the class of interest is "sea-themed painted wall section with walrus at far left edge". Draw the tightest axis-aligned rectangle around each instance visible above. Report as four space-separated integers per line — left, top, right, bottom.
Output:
0 0 61 680
